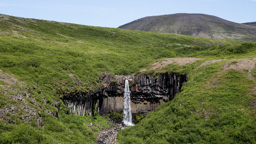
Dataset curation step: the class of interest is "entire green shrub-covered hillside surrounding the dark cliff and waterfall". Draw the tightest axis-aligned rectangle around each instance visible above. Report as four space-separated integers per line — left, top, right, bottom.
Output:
0 15 256 144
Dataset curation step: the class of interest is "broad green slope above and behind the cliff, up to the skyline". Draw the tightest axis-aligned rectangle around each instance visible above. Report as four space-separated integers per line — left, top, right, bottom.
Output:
0 14 244 101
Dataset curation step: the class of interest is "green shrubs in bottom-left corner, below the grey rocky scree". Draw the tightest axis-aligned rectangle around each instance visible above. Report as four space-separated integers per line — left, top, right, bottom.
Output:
0 108 114 144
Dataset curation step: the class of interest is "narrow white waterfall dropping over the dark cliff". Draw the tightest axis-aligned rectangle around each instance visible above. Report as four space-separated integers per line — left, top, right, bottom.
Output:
123 79 134 126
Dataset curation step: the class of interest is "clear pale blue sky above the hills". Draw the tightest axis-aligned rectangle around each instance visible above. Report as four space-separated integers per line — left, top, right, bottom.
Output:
0 0 256 27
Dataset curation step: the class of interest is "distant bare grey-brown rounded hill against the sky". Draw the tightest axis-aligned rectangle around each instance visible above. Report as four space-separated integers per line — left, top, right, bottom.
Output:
119 14 256 41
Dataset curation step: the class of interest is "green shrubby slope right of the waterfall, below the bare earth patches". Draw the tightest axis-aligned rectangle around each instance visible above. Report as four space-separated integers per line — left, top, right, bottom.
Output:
118 63 256 144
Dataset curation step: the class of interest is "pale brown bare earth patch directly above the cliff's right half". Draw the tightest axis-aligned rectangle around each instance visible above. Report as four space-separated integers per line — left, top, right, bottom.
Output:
140 58 201 72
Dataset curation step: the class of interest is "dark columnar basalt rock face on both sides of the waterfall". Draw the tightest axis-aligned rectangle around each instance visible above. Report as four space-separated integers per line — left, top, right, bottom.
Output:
63 73 187 121
